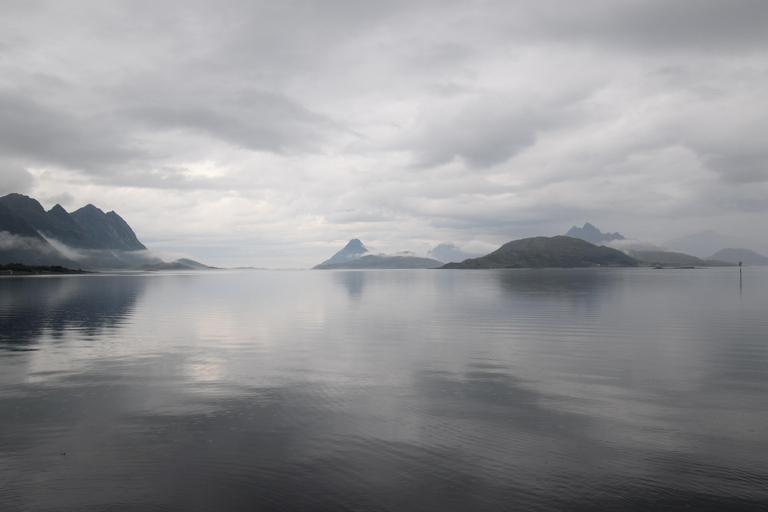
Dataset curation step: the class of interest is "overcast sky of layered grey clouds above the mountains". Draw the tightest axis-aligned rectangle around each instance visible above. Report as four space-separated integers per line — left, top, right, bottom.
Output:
0 0 768 268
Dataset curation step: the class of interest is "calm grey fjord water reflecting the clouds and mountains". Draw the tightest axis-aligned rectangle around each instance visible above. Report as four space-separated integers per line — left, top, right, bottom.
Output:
0 268 768 511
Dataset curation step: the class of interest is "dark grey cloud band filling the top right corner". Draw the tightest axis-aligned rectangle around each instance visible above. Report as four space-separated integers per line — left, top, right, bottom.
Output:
502 0 768 52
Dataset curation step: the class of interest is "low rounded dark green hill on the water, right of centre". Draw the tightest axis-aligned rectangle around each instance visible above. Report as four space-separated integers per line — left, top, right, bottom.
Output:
441 235 638 269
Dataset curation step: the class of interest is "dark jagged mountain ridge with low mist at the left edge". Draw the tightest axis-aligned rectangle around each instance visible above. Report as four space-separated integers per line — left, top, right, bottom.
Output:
0 194 207 269
